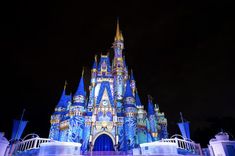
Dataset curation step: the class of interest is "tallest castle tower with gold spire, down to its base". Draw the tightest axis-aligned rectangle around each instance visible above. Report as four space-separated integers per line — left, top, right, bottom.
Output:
112 20 128 150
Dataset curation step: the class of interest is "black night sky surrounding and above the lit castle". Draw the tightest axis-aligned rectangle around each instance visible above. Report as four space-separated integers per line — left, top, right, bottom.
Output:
0 0 235 145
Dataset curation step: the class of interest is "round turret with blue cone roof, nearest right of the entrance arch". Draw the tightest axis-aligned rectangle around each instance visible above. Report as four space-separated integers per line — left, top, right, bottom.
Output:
124 80 137 150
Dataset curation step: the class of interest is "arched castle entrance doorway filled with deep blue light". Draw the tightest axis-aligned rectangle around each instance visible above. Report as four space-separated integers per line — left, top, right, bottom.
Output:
93 134 114 151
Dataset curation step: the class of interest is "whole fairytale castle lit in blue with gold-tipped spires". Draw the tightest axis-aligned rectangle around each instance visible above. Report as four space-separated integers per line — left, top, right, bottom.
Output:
49 22 168 151
